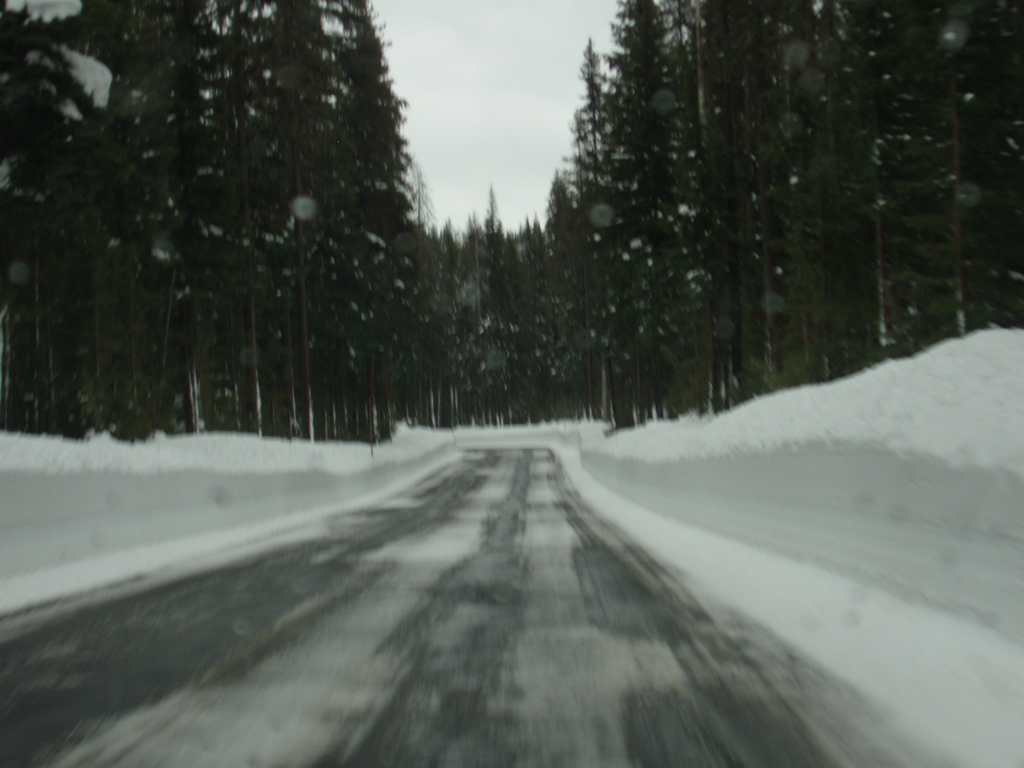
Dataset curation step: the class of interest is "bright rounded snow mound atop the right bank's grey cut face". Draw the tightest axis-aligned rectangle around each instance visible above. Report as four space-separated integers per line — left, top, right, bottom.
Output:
595 330 1024 476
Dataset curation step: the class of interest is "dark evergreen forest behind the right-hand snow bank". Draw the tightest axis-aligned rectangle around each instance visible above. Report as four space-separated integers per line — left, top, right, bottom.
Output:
548 0 1024 424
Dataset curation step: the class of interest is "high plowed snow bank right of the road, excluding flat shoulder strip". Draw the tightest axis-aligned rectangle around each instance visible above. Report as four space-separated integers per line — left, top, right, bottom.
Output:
582 331 1024 647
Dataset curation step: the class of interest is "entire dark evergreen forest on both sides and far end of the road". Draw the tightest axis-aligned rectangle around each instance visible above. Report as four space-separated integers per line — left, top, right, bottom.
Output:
0 0 1024 439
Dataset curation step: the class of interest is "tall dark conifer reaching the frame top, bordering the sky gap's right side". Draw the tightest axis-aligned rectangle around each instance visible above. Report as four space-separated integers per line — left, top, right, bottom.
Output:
605 0 679 423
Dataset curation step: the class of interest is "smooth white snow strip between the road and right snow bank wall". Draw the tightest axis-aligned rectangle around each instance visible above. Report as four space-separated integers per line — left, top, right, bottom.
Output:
558 450 1024 768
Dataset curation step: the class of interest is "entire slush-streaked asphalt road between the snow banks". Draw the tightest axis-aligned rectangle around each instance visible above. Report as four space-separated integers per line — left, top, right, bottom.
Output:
0 451 921 768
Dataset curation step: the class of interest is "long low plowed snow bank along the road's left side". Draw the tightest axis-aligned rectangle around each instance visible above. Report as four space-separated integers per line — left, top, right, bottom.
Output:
0 429 457 614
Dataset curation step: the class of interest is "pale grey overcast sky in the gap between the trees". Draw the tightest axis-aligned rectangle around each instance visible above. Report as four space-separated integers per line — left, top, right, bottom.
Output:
373 0 617 228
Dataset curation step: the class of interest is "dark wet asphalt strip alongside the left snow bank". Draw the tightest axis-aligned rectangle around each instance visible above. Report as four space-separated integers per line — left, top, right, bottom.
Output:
0 456 498 768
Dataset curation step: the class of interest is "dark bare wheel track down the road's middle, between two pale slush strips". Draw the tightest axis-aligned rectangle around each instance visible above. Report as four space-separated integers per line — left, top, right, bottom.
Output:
314 452 531 768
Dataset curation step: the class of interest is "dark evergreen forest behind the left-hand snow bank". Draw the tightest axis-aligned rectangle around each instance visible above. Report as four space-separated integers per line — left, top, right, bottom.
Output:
0 0 417 438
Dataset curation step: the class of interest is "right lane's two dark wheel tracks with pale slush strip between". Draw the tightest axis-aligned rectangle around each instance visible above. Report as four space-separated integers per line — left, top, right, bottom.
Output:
314 451 838 768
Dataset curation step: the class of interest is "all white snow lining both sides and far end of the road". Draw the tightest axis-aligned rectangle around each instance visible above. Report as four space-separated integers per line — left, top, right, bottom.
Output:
0 331 1024 768
